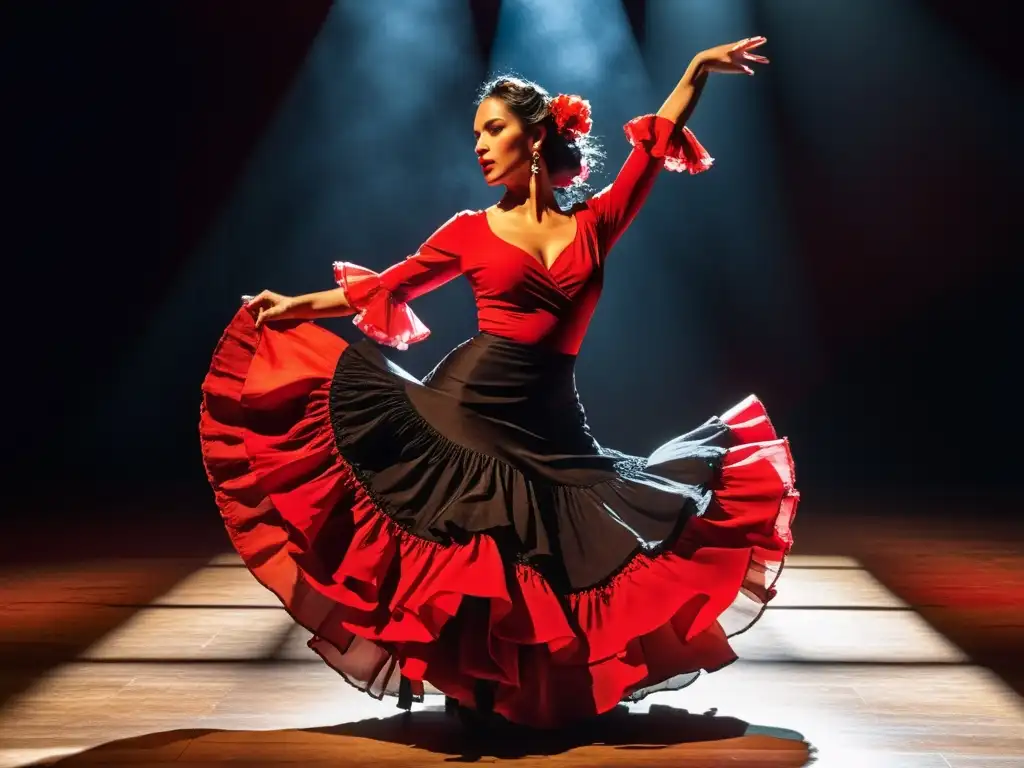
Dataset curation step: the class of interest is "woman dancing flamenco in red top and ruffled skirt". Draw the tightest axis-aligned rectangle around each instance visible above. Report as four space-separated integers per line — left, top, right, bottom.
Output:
195 38 798 727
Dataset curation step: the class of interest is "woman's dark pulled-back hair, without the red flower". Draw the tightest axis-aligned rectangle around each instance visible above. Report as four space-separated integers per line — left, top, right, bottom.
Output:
476 75 603 203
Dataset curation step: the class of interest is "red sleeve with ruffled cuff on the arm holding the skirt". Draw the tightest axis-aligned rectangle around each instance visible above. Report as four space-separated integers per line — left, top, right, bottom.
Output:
334 211 471 349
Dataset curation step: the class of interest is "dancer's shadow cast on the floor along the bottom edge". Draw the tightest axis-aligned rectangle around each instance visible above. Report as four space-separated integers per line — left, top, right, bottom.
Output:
39 705 813 768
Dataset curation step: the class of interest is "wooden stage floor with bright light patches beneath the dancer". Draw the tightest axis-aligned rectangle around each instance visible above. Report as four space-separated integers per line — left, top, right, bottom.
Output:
0 505 1024 768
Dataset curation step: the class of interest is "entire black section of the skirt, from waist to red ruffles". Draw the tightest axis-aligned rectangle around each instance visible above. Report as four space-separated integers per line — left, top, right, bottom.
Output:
330 335 729 594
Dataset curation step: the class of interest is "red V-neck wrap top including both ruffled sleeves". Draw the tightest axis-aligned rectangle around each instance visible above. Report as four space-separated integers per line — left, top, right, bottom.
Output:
335 115 712 354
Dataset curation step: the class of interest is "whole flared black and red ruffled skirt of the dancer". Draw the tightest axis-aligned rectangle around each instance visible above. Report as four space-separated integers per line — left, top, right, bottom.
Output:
200 309 799 727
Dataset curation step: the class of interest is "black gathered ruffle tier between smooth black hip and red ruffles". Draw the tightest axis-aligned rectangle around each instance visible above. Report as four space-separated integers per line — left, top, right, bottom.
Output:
331 345 728 596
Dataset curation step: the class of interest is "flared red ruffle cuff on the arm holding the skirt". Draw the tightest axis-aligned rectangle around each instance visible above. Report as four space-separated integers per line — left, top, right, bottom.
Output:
334 261 430 349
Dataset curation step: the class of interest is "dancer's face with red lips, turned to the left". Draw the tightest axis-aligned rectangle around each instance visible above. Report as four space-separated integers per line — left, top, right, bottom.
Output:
473 97 543 186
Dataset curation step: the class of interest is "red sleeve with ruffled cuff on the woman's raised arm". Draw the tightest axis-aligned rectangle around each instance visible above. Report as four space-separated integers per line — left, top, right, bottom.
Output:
588 115 714 260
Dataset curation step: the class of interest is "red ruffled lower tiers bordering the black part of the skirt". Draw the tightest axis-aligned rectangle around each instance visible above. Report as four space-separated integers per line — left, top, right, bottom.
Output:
200 310 798 727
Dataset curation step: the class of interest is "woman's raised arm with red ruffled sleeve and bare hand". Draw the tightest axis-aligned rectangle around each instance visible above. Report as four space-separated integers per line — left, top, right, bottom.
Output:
589 37 768 255
